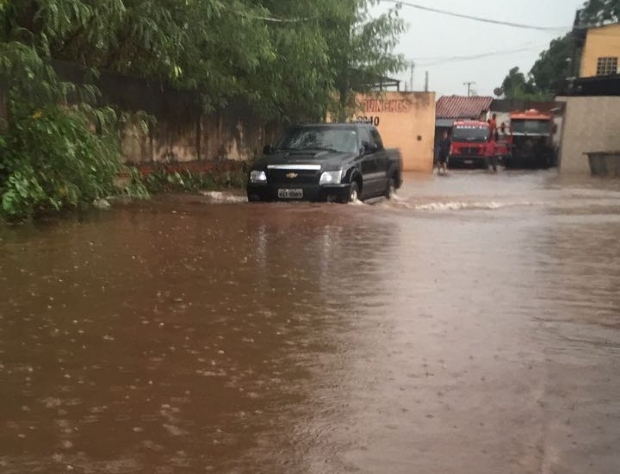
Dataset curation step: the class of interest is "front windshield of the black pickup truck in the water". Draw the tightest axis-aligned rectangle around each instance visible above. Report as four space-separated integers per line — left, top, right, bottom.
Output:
276 127 359 153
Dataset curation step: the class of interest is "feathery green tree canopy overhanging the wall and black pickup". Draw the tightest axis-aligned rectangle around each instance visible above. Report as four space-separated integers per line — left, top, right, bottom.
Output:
0 0 405 121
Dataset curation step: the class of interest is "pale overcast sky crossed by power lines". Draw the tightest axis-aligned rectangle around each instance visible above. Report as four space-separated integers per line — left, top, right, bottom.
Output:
373 0 583 98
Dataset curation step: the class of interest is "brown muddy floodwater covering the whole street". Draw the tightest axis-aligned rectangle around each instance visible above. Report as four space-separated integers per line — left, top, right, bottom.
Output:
0 171 620 474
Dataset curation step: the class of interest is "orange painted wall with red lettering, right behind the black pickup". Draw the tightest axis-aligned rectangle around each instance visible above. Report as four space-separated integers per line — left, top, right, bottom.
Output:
356 92 435 172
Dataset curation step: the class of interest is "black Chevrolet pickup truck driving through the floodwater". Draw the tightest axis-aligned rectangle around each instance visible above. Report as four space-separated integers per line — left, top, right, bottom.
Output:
247 123 402 203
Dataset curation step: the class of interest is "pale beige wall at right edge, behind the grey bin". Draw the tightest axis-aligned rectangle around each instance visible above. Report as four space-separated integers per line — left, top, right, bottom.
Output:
556 97 620 174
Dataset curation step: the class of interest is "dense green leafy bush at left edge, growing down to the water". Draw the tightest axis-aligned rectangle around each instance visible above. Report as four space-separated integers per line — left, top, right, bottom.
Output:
0 32 145 220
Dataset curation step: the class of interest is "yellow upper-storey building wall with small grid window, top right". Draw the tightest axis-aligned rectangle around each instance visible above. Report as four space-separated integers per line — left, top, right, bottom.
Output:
579 24 620 77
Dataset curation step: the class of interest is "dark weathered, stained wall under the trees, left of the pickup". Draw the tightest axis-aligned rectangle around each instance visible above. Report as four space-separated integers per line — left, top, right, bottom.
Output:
52 61 279 163
